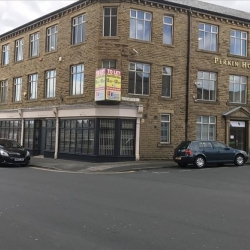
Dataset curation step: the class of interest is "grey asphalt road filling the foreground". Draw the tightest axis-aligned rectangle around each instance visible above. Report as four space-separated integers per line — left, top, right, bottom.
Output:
0 165 250 250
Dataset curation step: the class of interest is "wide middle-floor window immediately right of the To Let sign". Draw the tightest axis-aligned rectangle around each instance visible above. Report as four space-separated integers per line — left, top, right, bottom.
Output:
128 63 150 95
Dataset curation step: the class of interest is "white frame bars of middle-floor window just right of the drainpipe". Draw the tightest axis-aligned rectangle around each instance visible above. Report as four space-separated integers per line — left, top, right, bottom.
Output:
196 71 217 102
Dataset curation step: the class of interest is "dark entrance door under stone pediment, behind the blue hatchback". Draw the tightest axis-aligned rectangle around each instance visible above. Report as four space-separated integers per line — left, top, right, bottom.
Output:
229 127 246 150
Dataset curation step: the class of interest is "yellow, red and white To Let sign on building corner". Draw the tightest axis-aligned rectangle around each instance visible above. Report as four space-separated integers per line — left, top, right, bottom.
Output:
95 69 121 101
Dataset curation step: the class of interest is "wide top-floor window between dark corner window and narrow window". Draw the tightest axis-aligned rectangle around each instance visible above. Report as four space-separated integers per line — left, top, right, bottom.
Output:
130 10 152 41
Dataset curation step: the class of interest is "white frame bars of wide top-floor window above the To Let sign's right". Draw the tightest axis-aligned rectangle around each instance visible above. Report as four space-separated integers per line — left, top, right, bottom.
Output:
130 9 152 41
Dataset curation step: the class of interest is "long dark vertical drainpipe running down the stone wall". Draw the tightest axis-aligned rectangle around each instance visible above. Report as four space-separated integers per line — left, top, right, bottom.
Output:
185 8 192 140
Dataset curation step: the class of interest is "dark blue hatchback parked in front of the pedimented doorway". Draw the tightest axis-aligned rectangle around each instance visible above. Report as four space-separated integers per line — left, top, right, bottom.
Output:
173 141 248 168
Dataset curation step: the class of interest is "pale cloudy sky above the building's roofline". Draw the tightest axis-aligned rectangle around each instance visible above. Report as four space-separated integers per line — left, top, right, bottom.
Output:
0 0 250 34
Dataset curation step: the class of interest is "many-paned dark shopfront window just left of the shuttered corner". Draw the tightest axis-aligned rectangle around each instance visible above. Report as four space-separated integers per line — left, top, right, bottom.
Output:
59 119 95 154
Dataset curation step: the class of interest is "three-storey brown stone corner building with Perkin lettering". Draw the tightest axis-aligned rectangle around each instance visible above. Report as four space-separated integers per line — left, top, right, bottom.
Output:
0 0 250 161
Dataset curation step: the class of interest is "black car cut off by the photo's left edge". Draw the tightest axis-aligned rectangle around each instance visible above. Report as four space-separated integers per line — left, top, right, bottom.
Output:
0 138 30 166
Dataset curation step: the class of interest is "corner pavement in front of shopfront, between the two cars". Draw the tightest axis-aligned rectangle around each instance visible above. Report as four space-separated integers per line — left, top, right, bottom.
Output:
29 156 174 173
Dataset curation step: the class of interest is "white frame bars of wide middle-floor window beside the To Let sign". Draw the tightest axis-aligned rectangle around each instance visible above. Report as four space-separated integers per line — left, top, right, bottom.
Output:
128 62 151 96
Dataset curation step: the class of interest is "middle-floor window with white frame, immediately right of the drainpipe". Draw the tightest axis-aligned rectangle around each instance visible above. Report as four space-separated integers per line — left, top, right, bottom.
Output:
196 71 217 101
